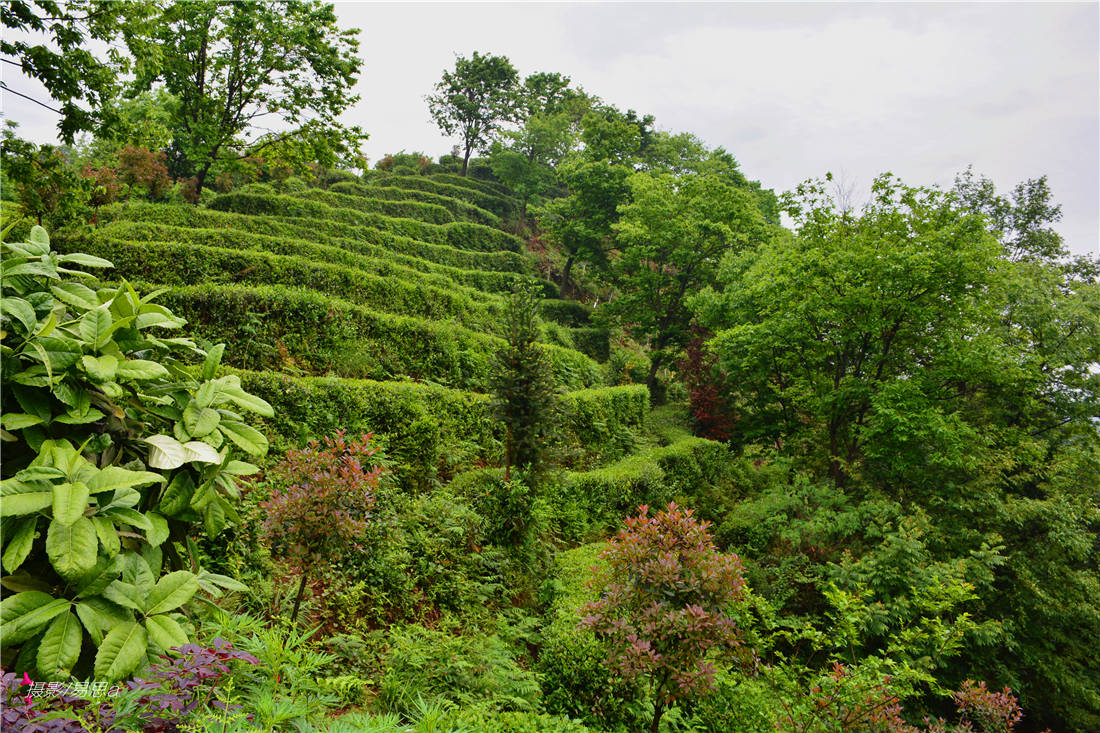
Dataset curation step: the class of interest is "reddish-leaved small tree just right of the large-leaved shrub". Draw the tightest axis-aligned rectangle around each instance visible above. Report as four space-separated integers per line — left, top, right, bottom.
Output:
262 430 384 562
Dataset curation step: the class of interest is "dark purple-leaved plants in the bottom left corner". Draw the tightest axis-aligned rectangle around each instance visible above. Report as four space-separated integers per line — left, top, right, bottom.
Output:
0 638 259 733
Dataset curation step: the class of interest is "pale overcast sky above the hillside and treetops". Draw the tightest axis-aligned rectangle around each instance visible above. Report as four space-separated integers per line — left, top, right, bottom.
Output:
3 2 1100 253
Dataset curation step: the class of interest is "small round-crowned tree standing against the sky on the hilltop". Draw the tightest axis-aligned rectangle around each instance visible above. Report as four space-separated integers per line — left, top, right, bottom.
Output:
427 51 520 176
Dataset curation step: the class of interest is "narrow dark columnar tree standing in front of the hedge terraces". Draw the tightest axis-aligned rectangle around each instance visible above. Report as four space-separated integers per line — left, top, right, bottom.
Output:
492 285 558 481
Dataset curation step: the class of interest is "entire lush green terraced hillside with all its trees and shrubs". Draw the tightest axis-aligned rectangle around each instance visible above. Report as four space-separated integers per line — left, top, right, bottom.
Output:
0 15 1100 733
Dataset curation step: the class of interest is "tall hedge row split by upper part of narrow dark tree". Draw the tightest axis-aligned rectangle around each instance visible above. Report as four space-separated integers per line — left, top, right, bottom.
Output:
108 283 602 391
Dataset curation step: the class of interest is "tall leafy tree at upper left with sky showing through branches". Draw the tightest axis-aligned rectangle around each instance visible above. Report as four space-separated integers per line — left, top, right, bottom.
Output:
133 0 364 193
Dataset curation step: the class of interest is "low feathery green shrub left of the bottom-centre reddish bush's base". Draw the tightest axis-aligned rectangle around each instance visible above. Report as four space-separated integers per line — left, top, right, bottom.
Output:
378 626 539 714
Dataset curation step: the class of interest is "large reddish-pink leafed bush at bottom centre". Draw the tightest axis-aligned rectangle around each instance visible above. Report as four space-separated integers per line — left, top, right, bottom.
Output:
581 504 745 725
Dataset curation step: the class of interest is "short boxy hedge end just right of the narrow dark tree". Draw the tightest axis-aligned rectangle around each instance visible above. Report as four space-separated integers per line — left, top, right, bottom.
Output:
562 384 649 464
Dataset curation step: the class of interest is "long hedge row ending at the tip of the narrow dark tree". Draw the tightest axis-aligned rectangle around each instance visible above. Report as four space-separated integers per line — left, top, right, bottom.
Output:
58 238 503 332
